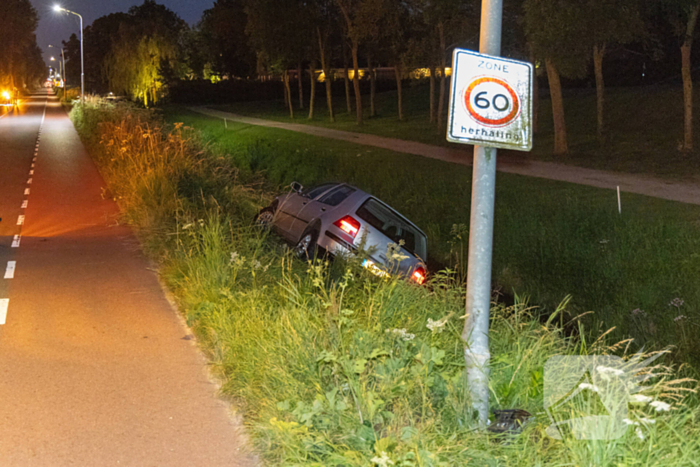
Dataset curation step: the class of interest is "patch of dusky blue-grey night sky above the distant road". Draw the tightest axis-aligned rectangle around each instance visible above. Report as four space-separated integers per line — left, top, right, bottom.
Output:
32 0 214 67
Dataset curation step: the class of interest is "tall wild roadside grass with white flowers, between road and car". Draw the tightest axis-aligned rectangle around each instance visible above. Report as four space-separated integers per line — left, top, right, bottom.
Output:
71 100 700 466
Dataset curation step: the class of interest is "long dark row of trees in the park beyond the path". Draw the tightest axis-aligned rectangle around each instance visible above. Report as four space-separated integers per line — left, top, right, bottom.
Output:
61 0 700 154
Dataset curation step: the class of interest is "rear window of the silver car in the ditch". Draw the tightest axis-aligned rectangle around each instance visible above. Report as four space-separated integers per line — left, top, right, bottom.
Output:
357 198 427 259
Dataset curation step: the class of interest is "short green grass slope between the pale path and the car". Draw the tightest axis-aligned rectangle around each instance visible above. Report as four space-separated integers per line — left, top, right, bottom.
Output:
168 107 700 370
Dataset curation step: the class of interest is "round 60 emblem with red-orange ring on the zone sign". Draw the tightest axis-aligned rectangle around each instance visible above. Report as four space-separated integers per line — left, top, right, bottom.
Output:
464 76 520 127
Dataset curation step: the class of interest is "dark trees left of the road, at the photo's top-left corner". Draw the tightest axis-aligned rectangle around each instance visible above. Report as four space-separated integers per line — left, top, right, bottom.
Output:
0 0 48 89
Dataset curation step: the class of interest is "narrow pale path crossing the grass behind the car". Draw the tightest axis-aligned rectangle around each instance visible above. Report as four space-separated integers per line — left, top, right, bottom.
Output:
189 107 700 205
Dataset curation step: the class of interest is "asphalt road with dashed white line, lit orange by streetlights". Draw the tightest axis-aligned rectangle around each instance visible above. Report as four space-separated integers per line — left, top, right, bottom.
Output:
0 93 254 466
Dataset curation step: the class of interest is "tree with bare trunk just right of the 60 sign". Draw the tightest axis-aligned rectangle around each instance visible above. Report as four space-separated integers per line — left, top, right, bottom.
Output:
523 0 590 155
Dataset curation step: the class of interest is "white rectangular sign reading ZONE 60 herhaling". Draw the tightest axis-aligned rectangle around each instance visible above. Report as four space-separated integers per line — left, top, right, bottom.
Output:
447 49 533 151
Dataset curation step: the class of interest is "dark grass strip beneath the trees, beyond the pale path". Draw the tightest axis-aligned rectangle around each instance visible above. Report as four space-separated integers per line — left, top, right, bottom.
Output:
211 85 700 180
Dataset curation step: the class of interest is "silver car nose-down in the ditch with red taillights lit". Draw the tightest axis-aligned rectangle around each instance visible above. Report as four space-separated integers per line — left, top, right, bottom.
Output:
256 182 428 284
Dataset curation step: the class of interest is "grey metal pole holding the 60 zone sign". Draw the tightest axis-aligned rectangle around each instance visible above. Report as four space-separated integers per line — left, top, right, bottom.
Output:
462 0 503 426
